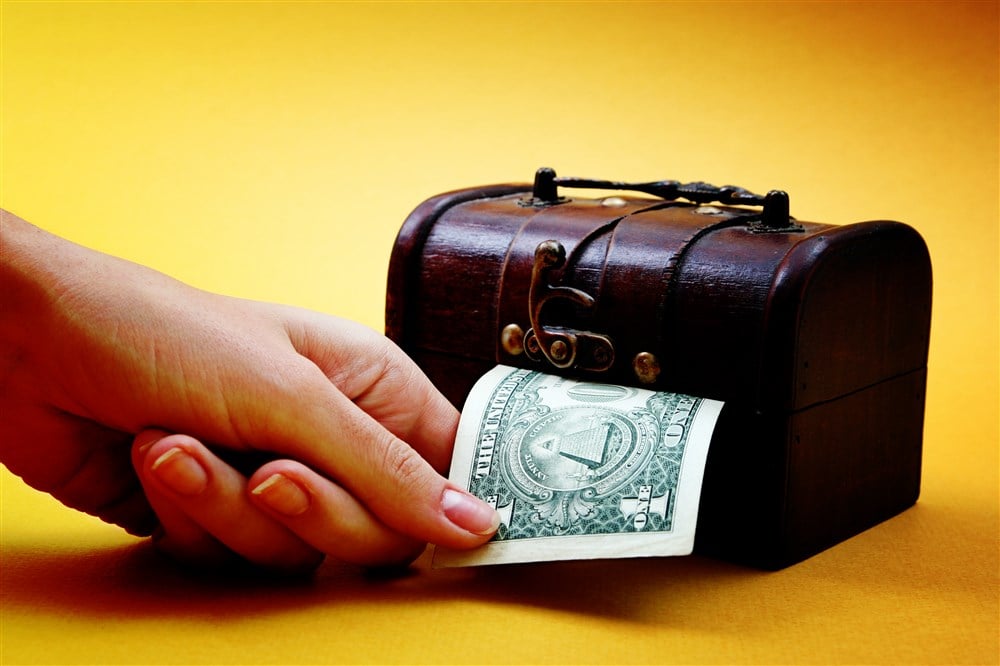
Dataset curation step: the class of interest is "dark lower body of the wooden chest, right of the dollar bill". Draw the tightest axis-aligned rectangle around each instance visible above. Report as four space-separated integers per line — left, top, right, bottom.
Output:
695 369 926 570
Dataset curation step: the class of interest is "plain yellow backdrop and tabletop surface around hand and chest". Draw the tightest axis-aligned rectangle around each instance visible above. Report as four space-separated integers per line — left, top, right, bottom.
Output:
0 0 1000 664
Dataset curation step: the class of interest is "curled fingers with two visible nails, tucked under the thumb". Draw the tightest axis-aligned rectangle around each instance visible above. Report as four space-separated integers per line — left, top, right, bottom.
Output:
133 431 424 570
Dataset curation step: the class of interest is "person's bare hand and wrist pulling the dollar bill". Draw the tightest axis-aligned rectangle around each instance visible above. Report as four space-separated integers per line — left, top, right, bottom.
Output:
0 211 498 571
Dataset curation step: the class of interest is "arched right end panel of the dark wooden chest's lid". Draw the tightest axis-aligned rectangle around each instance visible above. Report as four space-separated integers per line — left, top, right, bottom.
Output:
758 221 932 410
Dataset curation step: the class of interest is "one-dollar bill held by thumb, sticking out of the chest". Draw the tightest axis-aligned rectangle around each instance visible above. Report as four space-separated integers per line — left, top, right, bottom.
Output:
433 366 722 567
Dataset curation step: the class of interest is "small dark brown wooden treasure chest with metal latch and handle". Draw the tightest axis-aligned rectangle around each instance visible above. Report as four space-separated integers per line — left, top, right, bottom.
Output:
386 169 931 569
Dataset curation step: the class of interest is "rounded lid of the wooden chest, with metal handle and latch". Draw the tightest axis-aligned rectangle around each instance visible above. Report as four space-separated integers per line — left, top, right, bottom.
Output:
387 170 930 409
